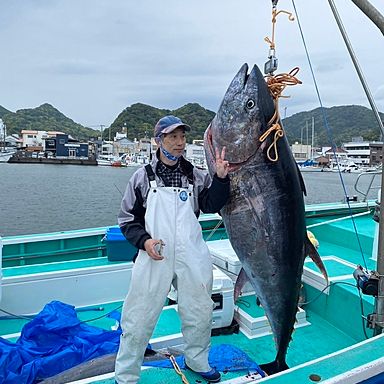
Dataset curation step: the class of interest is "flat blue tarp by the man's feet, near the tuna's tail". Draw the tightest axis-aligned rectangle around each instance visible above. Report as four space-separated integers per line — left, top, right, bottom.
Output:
144 344 264 377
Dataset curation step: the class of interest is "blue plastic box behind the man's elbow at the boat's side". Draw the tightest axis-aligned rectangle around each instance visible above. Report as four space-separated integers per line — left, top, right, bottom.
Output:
103 227 138 261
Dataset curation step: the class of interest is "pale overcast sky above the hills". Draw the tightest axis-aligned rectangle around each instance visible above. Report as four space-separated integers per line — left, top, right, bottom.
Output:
0 0 384 127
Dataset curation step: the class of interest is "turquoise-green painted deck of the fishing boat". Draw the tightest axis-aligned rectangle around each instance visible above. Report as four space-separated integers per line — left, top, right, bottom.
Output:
0 202 384 384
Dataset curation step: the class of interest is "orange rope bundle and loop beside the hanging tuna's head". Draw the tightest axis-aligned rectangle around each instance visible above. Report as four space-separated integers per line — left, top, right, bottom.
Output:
259 67 302 162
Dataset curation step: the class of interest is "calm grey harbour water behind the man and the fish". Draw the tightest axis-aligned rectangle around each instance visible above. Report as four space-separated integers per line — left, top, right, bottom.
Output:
0 163 380 236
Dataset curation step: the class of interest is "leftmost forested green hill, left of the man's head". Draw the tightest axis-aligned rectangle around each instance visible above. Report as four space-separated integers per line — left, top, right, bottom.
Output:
0 104 98 140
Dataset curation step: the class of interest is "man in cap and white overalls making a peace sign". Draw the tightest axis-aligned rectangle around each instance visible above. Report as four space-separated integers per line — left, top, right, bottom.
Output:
115 116 230 384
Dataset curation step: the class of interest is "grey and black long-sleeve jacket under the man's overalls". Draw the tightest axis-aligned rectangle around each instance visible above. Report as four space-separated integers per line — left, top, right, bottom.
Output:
118 156 230 249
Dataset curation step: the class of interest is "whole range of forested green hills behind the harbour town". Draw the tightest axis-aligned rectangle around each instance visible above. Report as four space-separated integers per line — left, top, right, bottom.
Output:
0 103 384 146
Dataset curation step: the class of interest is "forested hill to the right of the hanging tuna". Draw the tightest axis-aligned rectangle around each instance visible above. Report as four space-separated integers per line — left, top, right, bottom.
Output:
283 105 384 146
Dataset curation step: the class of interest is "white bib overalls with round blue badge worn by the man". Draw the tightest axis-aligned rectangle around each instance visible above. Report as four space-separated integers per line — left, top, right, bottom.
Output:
115 177 213 384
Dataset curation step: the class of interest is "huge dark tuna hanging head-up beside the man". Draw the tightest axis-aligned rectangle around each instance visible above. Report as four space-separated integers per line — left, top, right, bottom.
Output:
205 64 328 374
